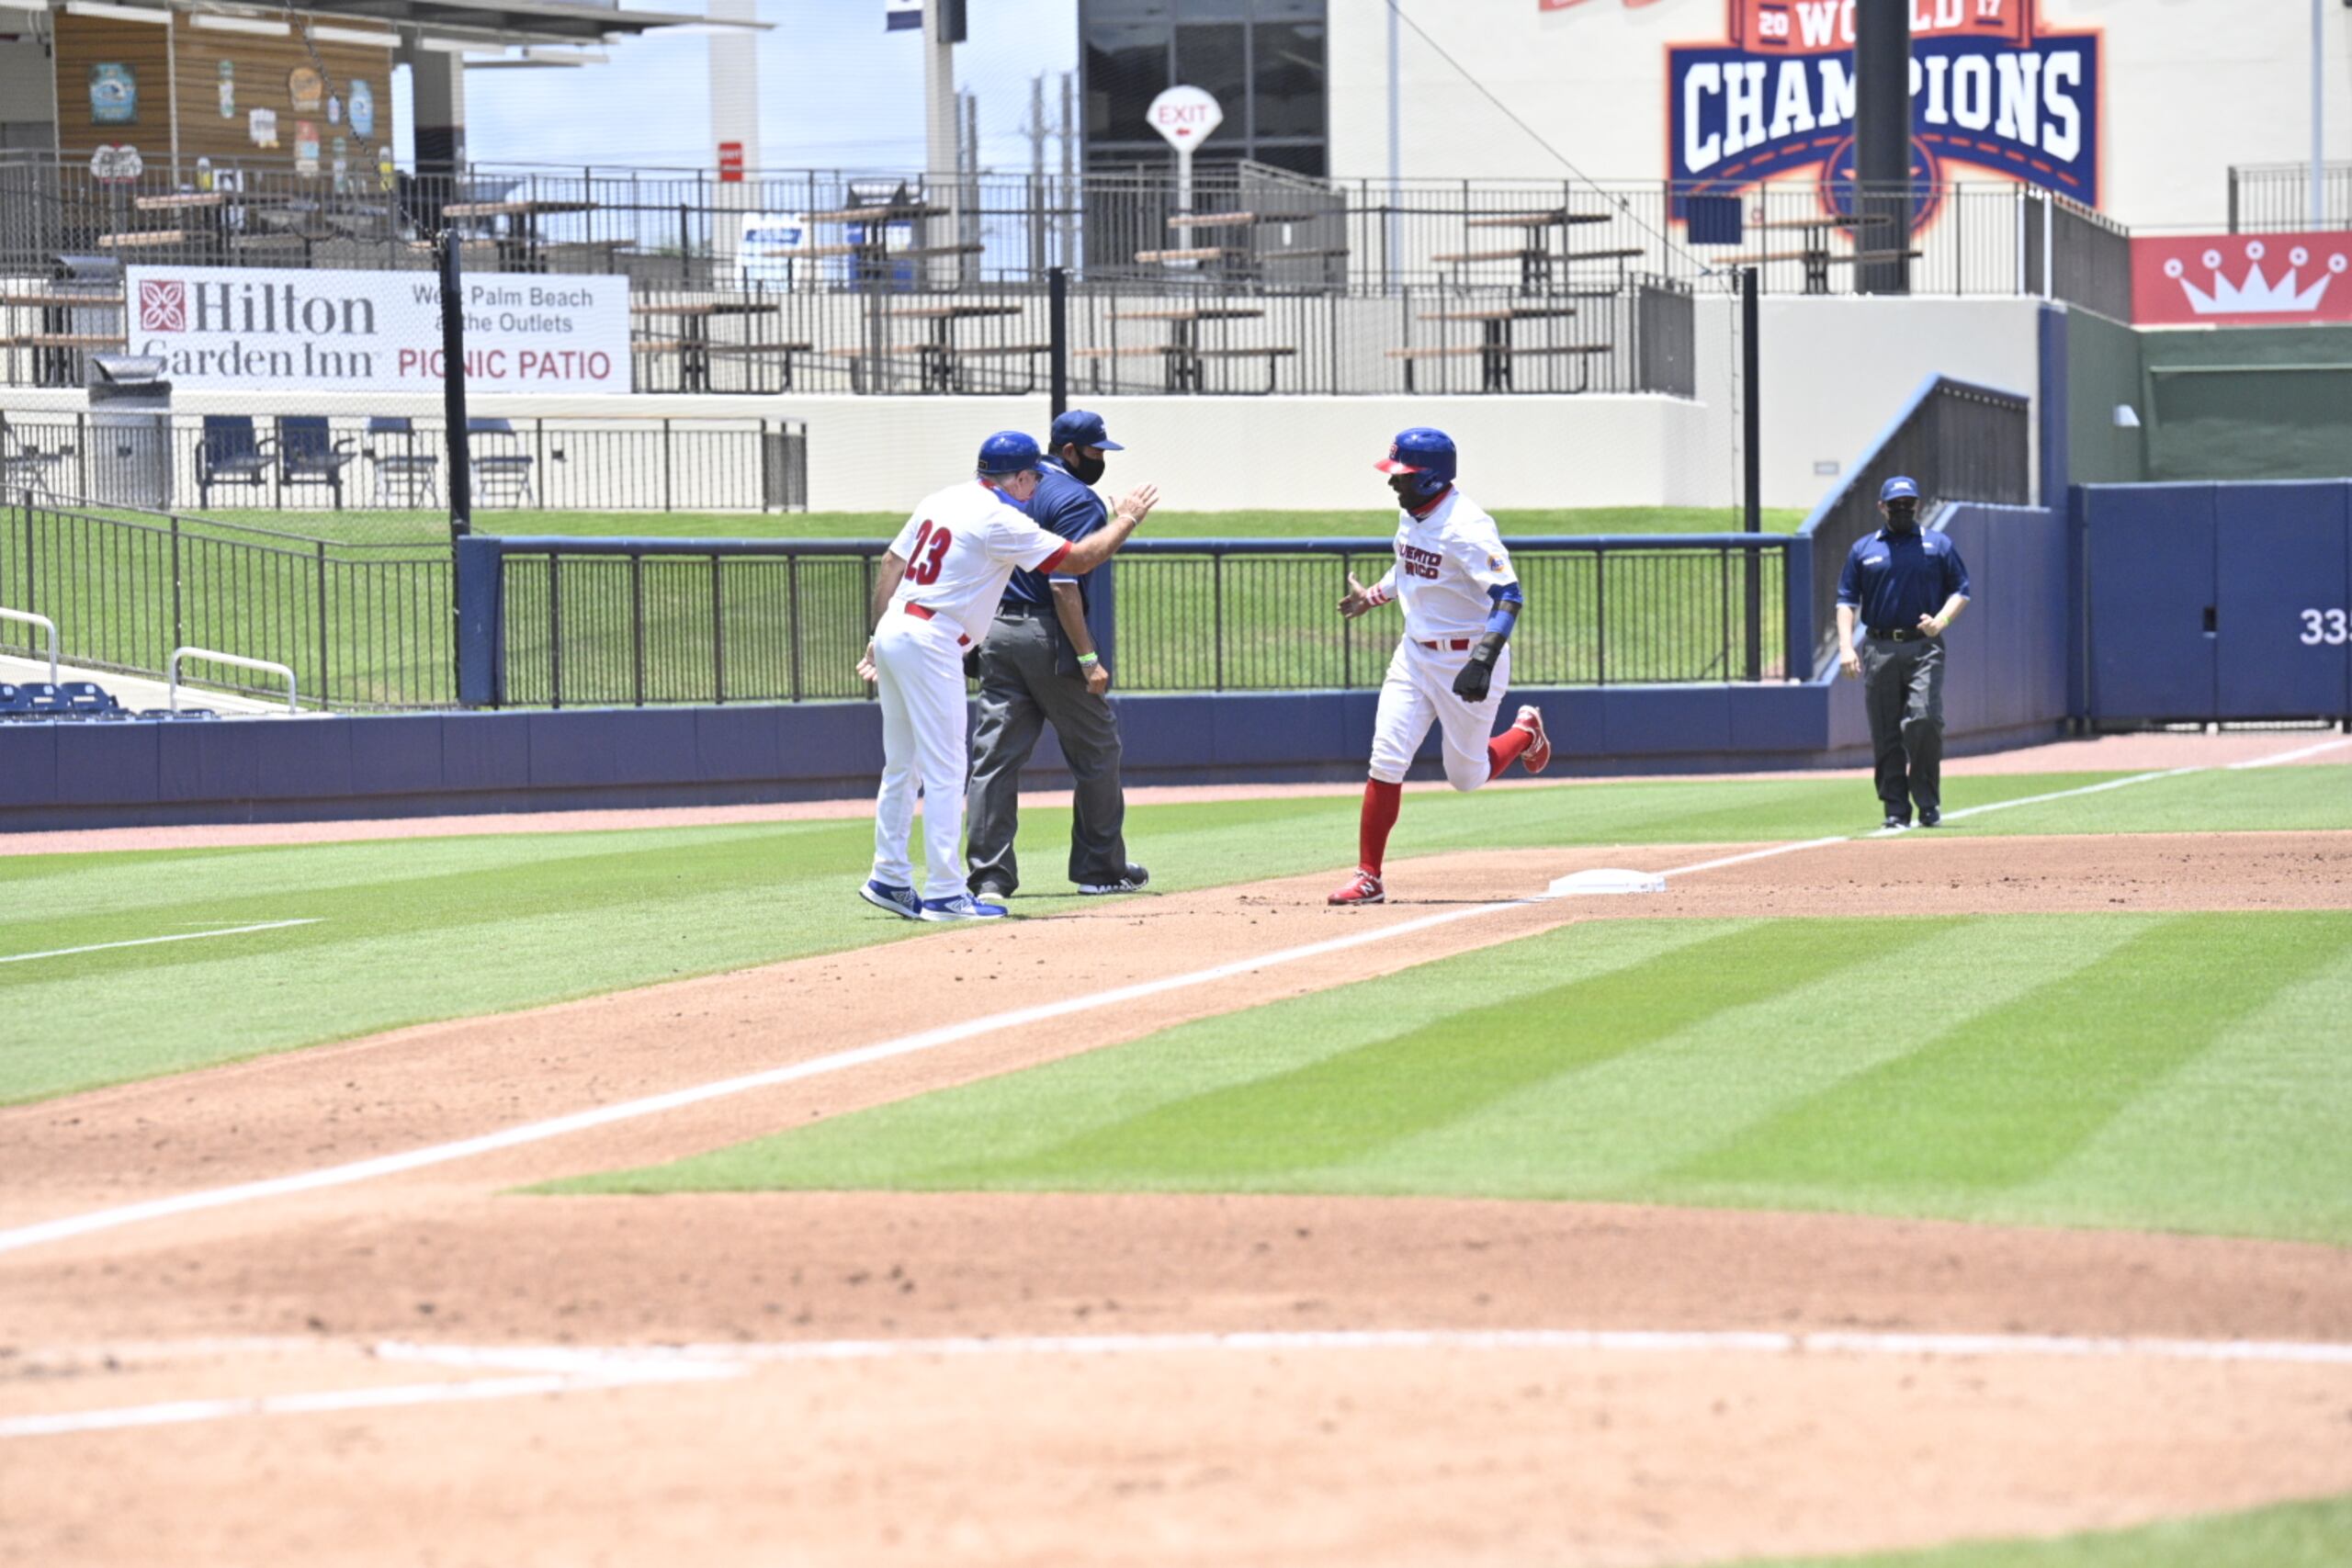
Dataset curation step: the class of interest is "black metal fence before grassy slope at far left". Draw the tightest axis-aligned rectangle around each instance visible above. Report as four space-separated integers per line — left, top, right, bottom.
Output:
0 499 457 707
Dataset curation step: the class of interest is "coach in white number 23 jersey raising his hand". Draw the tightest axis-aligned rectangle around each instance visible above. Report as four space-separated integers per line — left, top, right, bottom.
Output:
858 430 1159 919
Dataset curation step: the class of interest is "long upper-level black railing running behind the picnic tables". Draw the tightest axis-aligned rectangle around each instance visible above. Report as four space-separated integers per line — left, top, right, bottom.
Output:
0 152 2117 294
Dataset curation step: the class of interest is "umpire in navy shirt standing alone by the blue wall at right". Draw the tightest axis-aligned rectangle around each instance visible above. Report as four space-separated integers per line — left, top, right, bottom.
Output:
1837 478 1969 828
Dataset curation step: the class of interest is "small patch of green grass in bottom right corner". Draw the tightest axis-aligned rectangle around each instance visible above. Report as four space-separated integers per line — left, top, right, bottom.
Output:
1717 1497 2352 1568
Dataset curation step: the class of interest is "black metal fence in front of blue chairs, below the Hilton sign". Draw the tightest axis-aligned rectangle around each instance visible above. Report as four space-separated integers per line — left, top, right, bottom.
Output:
0 409 809 522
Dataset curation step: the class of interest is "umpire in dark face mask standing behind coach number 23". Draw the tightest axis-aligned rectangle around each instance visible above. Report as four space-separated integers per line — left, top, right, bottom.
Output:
967 409 1150 900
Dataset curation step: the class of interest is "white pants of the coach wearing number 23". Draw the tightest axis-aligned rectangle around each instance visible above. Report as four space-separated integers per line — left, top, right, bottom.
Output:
873 611 969 898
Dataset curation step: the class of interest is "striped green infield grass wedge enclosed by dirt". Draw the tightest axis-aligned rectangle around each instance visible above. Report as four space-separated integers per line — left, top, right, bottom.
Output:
564 915 2352 1241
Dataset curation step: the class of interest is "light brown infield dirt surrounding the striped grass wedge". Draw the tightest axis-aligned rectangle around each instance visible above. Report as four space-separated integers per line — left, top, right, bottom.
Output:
0 832 2352 1563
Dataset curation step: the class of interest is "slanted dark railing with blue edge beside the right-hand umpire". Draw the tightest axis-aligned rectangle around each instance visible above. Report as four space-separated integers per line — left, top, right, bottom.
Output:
1794 376 2032 677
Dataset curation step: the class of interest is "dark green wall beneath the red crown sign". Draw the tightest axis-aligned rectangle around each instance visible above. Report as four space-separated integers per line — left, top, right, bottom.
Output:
2065 310 2352 484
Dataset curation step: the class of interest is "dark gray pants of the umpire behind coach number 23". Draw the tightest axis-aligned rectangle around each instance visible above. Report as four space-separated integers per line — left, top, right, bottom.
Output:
965 606 1126 894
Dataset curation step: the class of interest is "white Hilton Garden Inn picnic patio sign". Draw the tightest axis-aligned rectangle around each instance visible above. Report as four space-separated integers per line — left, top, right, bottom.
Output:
125 265 630 392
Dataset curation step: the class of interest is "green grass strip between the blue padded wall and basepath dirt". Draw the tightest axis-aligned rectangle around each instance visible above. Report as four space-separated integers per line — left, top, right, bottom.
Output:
0 769 2352 1102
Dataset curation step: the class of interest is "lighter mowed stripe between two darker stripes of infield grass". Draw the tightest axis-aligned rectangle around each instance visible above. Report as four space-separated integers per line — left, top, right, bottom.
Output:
1331 917 2145 1199
